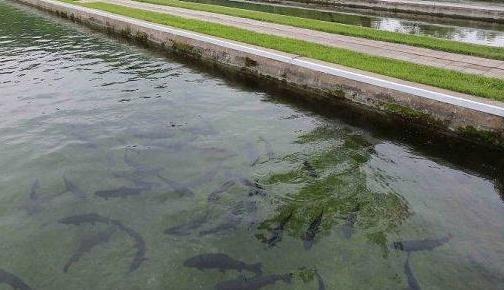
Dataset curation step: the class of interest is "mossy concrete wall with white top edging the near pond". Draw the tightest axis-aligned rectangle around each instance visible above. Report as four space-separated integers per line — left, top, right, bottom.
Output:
11 0 504 145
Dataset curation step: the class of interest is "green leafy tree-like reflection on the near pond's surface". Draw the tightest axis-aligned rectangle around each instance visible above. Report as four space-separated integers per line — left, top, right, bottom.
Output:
258 127 410 253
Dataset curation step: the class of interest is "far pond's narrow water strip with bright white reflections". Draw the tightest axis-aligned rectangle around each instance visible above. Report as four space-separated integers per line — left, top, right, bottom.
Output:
183 0 504 46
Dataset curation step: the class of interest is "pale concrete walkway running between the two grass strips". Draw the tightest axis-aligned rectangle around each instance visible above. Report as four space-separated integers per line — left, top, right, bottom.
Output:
94 0 504 79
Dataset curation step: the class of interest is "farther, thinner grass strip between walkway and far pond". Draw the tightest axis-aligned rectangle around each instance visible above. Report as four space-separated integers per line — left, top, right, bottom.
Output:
128 0 504 60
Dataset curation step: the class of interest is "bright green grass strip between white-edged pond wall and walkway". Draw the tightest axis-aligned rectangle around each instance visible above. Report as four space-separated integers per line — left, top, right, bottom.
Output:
80 2 504 101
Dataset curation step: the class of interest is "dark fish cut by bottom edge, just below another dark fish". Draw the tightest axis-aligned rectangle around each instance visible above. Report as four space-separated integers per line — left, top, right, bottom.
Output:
215 274 292 290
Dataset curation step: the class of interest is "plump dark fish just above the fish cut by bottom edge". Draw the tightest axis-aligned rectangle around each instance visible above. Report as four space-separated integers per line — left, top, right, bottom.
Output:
184 254 262 275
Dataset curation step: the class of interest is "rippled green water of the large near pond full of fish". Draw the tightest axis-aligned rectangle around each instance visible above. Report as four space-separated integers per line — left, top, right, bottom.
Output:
0 1 504 290
